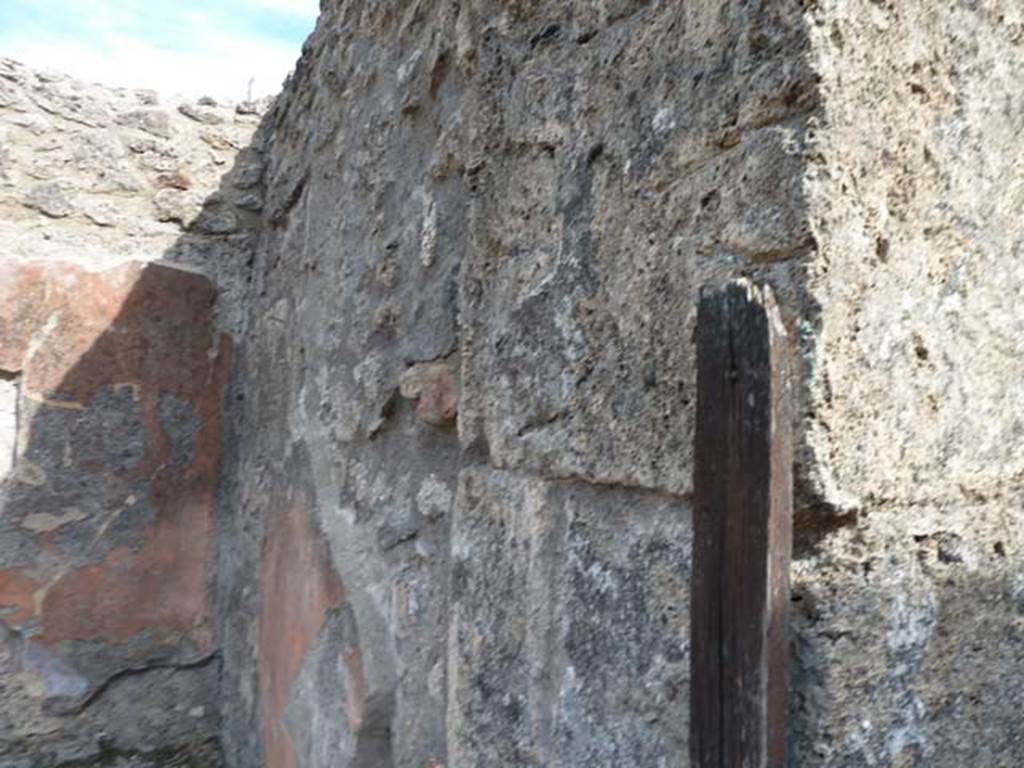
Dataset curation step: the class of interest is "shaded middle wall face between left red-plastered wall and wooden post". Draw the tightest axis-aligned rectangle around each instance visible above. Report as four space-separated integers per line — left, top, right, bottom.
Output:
223 0 816 768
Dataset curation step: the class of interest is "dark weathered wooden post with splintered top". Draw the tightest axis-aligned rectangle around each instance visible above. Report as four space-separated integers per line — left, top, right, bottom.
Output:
690 280 793 768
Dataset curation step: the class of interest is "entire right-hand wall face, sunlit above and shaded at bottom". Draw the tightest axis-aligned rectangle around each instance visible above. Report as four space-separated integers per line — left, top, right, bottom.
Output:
791 0 1024 768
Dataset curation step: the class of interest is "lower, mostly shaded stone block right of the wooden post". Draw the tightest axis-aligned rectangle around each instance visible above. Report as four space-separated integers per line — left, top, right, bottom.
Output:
790 520 1024 768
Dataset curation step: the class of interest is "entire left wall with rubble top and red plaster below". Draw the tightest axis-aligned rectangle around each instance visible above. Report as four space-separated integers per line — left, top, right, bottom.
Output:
0 59 260 768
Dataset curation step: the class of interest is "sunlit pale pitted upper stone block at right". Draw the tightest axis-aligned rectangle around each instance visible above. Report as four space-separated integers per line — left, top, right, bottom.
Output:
807 2 1024 508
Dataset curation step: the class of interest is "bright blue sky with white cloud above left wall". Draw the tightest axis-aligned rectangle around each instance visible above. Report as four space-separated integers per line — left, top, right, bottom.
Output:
0 0 319 100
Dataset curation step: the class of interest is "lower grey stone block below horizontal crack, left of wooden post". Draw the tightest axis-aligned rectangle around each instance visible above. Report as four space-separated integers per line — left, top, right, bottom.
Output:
449 469 691 766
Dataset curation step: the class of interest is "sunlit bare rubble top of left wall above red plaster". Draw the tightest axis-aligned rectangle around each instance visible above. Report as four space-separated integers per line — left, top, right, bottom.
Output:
0 57 266 331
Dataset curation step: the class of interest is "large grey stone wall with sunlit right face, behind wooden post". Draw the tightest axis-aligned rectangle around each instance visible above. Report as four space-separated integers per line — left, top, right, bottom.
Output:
225 1 1024 766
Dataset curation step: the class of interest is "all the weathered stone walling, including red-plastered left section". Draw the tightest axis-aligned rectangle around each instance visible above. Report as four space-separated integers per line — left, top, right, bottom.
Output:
0 0 1024 768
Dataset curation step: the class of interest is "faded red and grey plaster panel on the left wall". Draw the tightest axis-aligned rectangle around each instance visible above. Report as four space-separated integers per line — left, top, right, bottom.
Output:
0 259 231 760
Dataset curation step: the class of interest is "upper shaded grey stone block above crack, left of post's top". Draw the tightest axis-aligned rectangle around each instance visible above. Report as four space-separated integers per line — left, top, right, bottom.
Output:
460 3 816 493
